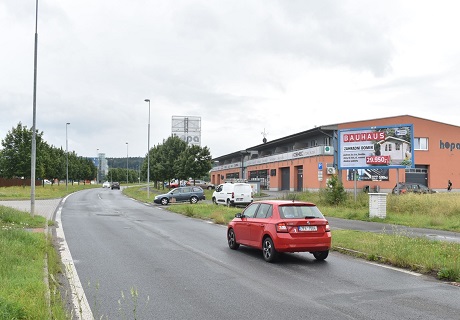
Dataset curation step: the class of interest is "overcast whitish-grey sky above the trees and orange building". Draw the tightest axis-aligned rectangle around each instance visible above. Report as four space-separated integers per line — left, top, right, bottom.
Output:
0 0 460 157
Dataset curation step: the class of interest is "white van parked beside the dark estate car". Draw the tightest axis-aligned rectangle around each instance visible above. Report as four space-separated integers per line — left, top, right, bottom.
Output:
212 183 253 207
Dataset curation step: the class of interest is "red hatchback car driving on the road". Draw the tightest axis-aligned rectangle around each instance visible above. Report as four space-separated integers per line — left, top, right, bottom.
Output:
227 200 331 262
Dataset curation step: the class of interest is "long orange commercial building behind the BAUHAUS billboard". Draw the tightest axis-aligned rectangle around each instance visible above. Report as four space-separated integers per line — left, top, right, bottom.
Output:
211 115 460 192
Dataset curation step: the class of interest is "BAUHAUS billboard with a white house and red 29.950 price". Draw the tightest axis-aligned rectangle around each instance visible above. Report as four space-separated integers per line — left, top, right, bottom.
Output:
338 124 414 169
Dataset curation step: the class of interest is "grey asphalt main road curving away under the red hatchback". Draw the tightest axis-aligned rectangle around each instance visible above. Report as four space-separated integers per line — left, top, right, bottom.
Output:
62 189 460 320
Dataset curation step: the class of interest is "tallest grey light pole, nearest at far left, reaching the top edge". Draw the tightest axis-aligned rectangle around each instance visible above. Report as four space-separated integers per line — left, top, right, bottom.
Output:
30 0 38 217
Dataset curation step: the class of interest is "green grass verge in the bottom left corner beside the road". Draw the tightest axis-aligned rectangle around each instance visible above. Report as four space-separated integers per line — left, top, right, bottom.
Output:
0 206 66 319
